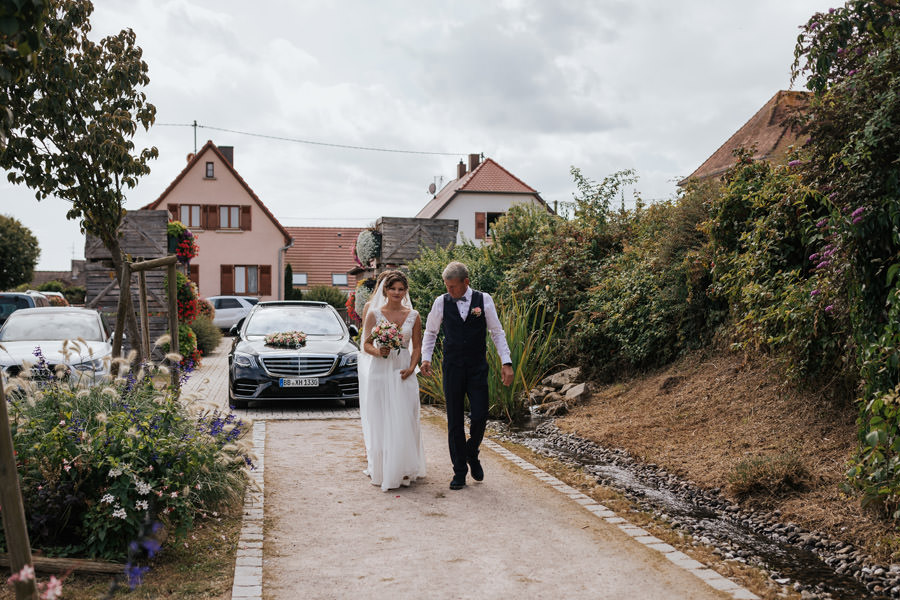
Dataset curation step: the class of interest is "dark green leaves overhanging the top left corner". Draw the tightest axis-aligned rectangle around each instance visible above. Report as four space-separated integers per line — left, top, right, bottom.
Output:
0 0 50 151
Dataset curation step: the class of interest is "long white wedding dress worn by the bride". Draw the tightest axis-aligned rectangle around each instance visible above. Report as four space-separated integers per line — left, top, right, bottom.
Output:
359 306 425 491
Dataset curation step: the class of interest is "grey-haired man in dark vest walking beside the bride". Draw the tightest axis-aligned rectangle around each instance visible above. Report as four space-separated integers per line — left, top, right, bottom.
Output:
421 262 513 490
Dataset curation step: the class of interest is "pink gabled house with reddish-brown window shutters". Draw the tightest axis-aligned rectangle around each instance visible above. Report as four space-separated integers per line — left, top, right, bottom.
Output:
143 141 292 300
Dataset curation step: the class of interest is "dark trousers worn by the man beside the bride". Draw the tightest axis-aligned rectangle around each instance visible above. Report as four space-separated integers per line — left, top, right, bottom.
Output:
443 362 488 477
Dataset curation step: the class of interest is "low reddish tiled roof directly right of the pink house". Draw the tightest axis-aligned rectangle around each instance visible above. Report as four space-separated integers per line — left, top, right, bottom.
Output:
285 227 363 288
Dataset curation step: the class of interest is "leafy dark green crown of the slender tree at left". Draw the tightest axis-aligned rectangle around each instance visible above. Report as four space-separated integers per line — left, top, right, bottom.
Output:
0 0 158 356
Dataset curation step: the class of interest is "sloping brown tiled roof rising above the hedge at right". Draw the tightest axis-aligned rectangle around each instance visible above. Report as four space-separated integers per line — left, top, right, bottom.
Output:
678 90 812 185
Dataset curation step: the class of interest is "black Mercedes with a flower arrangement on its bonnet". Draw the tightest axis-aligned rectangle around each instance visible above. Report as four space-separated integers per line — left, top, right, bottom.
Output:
228 301 359 408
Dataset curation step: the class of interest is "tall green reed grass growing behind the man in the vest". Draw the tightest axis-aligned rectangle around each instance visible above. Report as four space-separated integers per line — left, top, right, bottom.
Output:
419 294 560 422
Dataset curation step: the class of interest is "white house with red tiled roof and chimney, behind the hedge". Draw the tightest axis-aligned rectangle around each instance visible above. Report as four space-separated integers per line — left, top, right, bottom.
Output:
416 154 552 245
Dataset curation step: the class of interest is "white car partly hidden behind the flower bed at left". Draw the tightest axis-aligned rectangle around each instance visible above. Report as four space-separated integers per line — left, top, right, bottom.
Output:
0 306 112 381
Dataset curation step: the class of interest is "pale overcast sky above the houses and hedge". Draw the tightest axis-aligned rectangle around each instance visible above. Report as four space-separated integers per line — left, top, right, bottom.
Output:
0 0 836 270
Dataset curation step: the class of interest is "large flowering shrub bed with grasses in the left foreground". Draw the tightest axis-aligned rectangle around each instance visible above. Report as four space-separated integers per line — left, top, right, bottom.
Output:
0 354 252 560
